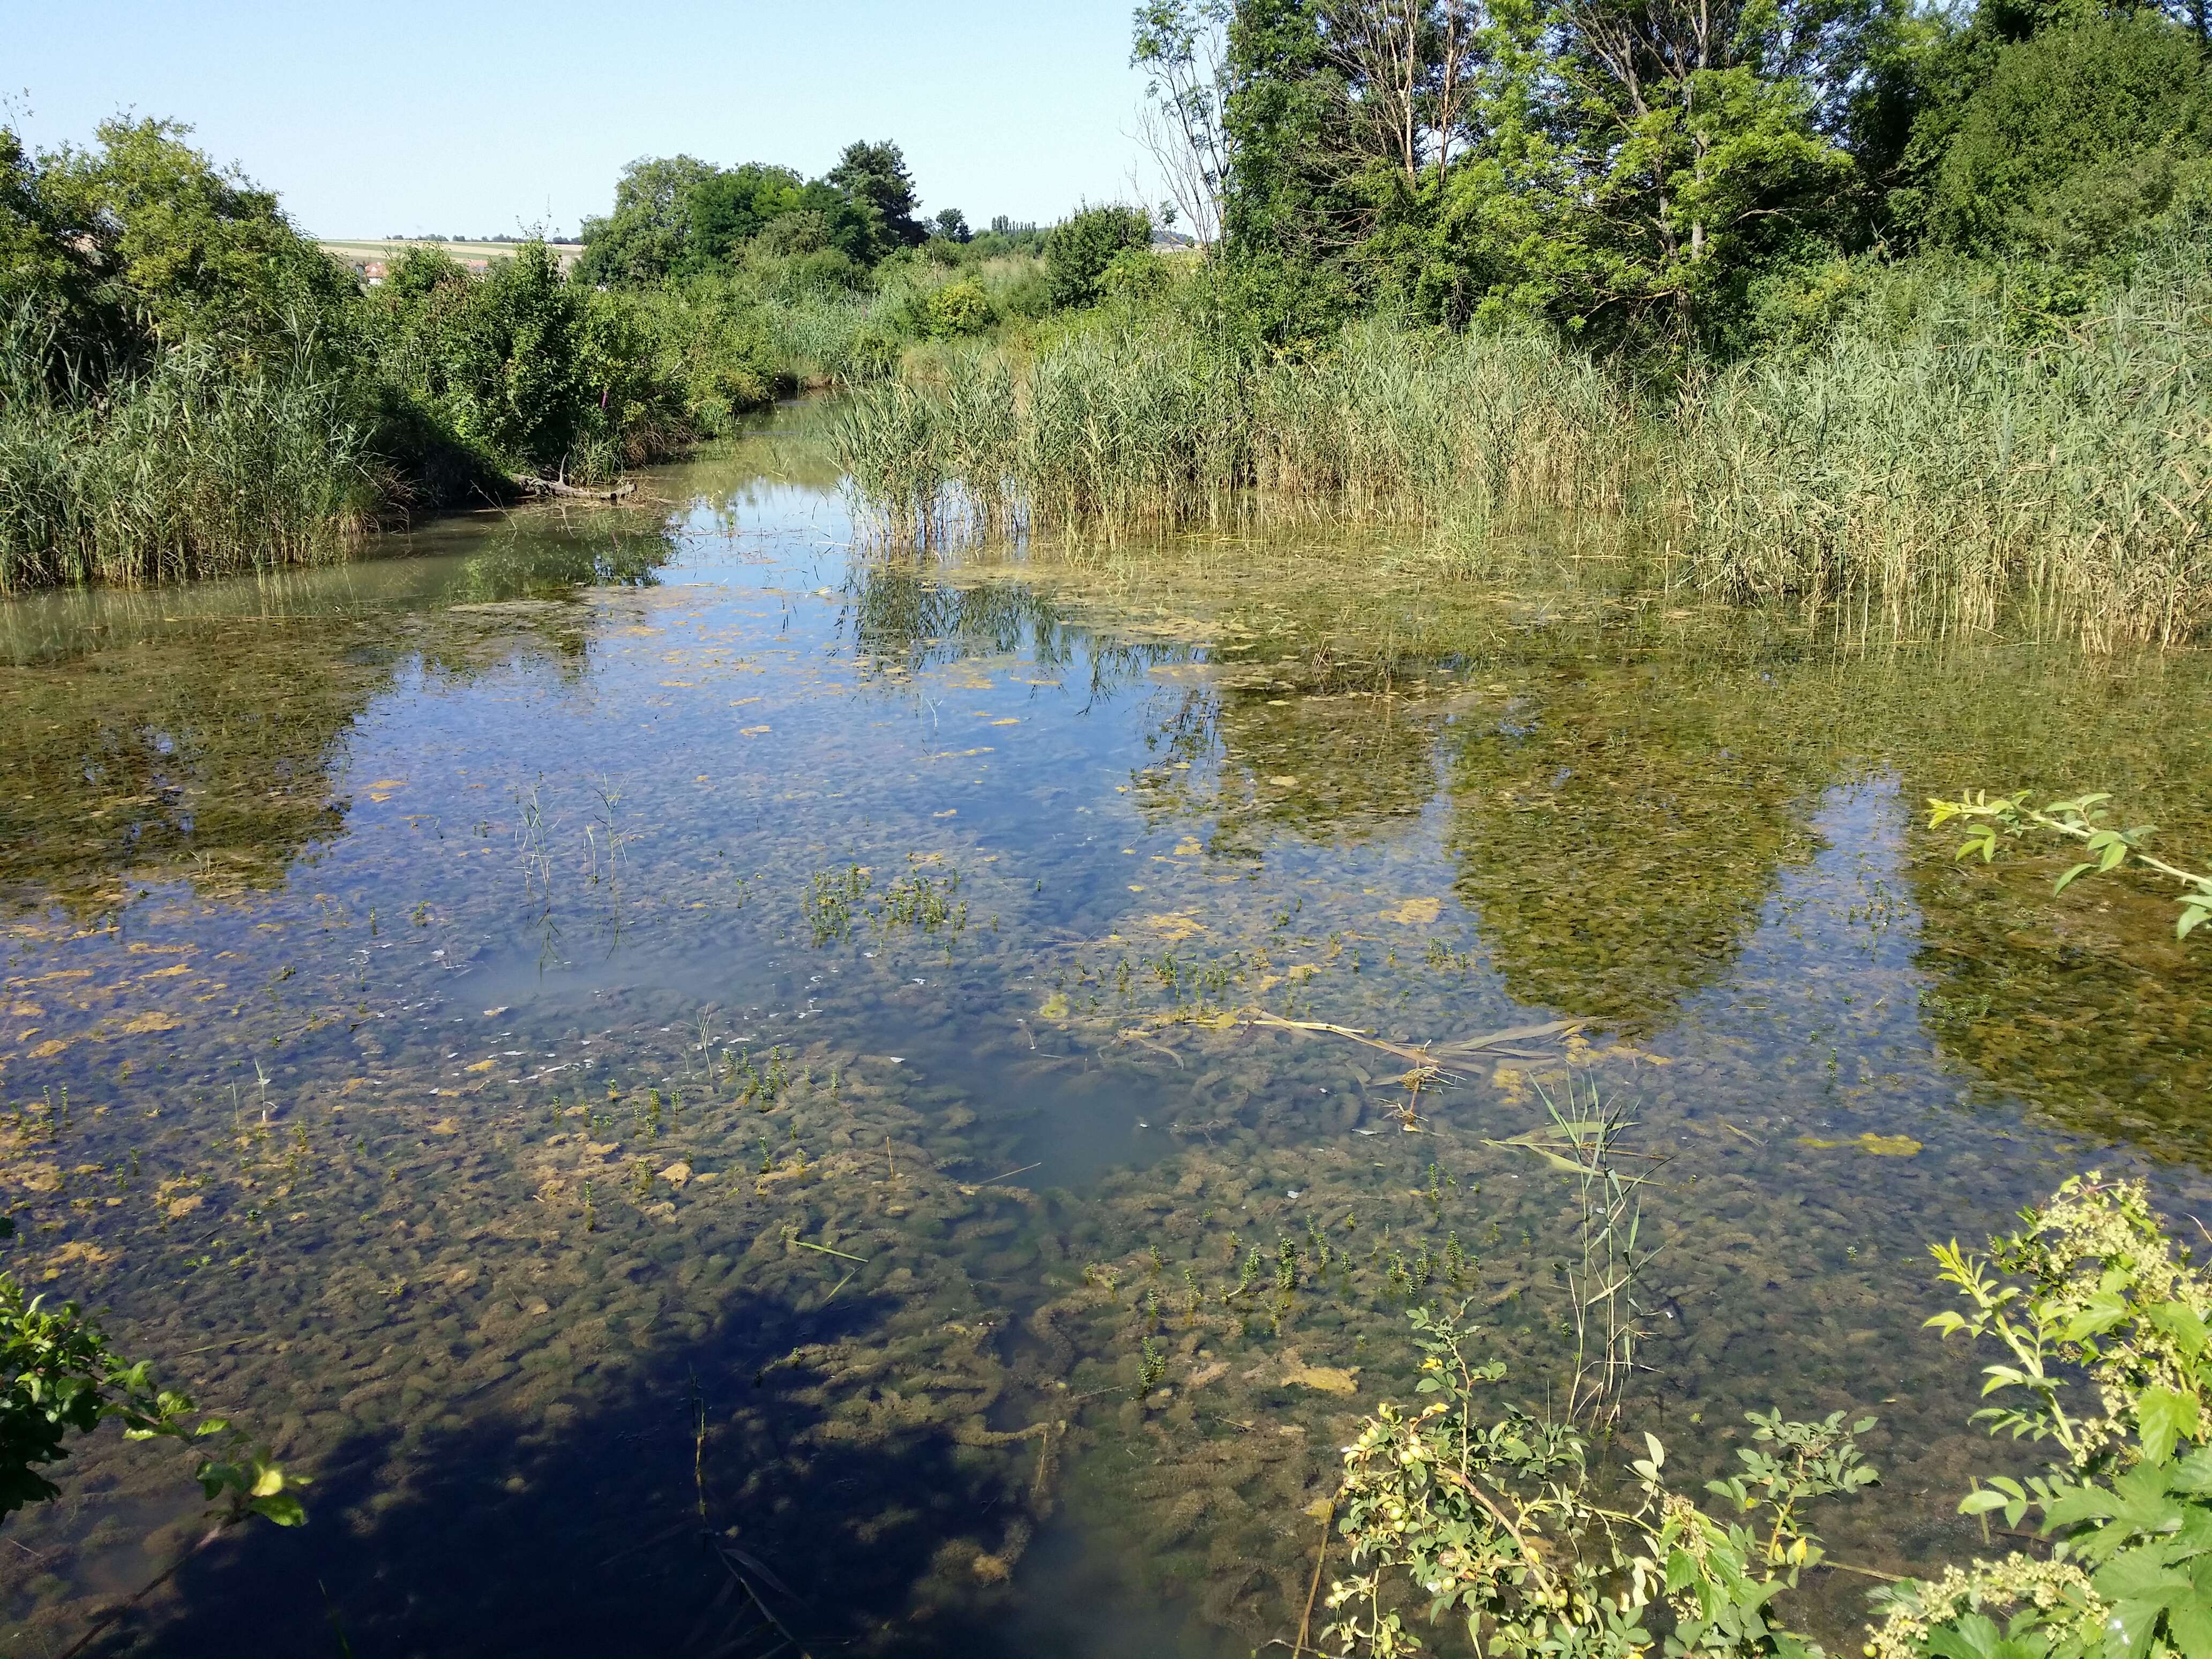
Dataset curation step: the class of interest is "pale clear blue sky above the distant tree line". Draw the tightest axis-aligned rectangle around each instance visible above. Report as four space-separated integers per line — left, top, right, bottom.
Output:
13 0 1157 237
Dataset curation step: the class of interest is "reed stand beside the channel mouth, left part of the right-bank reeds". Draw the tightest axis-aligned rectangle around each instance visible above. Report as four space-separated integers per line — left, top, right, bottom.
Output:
832 325 1641 544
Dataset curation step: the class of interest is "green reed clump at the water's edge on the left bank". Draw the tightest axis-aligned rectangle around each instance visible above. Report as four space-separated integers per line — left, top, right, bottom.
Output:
0 336 380 593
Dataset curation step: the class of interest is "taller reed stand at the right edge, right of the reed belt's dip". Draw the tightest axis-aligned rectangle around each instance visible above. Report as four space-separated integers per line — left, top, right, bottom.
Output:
1668 253 2212 648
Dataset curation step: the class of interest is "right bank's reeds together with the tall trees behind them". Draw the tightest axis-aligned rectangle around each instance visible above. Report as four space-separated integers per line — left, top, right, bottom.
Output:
845 0 2212 646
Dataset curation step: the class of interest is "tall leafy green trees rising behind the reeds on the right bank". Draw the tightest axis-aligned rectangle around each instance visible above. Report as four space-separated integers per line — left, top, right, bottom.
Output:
1133 0 2212 361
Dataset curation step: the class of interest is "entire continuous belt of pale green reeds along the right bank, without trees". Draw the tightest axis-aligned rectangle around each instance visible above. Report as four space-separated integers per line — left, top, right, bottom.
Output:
834 263 2212 648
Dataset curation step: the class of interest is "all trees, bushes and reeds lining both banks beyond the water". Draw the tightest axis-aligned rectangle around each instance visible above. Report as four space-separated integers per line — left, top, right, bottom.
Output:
0 0 2212 646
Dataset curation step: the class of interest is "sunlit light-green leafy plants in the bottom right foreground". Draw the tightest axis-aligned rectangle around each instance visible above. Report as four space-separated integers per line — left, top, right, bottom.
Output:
1325 1175 2212 1659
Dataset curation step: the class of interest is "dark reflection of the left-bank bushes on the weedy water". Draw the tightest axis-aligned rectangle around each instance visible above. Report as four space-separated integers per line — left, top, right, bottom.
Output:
0 515 675 920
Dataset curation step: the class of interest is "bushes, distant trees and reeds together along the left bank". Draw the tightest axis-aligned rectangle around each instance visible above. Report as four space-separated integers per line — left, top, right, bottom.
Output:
0 119 1051 591
